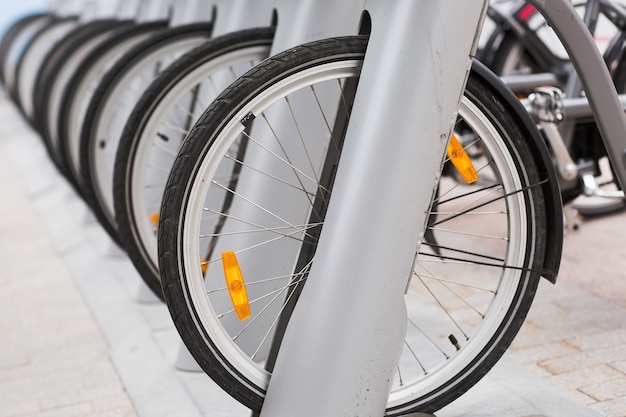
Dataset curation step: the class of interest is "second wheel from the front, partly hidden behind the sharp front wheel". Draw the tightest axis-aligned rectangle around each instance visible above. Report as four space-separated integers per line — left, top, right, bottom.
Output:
113 28 274 299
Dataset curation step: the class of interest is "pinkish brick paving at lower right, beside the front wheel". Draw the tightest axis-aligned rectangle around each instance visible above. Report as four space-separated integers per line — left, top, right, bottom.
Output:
506 208 626 417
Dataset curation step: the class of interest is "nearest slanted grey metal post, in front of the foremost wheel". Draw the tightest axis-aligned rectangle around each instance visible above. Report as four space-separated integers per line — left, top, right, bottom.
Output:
260 0 487 417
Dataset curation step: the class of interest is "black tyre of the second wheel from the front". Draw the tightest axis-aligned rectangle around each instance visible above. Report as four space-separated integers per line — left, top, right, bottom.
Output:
113 27 274 300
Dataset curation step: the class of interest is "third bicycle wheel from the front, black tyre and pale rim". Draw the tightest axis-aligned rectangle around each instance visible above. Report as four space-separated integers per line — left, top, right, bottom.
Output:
78 23 211 244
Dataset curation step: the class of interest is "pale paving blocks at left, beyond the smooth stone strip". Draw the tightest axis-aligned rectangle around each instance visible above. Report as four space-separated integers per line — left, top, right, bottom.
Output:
0 98 136 417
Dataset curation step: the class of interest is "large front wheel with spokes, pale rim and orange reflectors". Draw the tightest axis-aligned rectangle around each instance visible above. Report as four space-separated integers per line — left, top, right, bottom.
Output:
158 37 546 415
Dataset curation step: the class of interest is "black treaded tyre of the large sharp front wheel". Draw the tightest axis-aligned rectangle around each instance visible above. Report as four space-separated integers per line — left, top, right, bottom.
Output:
158 37 547 415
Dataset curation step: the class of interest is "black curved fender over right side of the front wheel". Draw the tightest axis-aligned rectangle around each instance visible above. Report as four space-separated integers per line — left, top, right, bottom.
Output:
472 60 563 284
